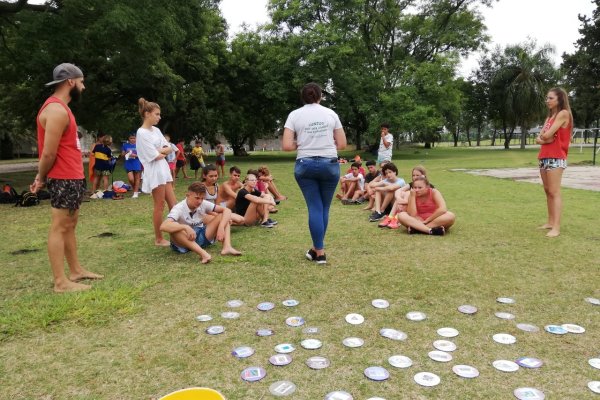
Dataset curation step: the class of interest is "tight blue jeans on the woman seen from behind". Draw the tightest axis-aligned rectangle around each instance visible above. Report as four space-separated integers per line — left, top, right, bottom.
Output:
294 157 340 250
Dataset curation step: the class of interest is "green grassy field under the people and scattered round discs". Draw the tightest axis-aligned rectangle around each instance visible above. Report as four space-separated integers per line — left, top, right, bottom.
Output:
0 148 600 400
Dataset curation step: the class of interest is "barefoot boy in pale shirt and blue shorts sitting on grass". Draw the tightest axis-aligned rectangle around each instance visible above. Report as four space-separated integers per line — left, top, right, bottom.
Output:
160 182 242 264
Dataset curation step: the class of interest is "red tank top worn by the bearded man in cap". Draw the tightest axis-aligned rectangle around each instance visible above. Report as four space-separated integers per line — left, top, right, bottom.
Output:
36 96 85 179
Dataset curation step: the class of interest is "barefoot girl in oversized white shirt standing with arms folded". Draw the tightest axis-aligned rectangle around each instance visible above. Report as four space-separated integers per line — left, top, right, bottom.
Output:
136 97 177 246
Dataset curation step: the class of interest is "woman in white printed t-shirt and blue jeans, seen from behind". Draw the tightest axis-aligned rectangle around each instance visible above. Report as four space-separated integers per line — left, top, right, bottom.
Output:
282 83 346 264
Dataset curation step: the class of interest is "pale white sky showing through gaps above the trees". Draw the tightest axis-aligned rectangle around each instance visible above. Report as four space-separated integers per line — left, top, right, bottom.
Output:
221 0 594 76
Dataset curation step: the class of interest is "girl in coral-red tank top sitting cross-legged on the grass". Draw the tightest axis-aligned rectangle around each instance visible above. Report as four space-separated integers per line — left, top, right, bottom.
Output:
398 176 456 236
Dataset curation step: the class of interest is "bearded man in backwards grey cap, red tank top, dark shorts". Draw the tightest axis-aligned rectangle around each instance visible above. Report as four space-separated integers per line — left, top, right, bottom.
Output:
30 63 103 293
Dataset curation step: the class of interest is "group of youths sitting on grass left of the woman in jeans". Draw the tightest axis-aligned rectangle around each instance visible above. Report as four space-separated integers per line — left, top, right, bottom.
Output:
160 164 286 264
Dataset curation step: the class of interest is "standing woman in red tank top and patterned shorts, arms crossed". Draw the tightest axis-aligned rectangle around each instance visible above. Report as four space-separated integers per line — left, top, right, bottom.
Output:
535 88 573 237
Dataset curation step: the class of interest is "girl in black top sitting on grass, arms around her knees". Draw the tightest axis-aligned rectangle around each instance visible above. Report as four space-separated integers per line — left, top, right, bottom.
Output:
235 174 277 228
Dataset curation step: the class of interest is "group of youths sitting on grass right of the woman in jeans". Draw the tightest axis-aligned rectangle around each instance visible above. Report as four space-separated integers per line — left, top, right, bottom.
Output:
336 161 456 236
